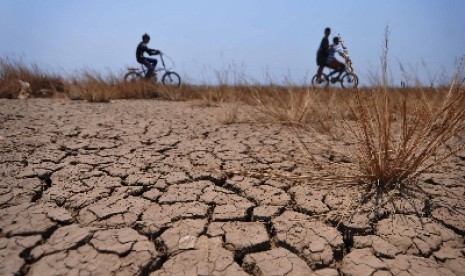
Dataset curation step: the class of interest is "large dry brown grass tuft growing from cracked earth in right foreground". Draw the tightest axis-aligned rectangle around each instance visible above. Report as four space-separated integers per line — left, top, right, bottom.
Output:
334 41 465 220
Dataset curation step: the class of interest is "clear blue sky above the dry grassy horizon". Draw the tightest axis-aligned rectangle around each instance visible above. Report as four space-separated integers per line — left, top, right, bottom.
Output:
0 0 465 86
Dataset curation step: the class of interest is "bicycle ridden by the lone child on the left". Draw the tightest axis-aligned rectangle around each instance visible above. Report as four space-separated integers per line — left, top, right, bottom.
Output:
124 52 181 86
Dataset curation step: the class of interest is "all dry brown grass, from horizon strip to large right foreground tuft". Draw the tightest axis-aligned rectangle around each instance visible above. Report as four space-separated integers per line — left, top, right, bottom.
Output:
0 48 465 224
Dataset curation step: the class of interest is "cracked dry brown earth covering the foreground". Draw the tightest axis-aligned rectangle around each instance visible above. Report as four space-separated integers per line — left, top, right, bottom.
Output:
0 99 465 276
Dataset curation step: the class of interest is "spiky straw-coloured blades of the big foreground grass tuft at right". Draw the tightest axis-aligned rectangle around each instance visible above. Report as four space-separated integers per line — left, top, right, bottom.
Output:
347 85 465 190
